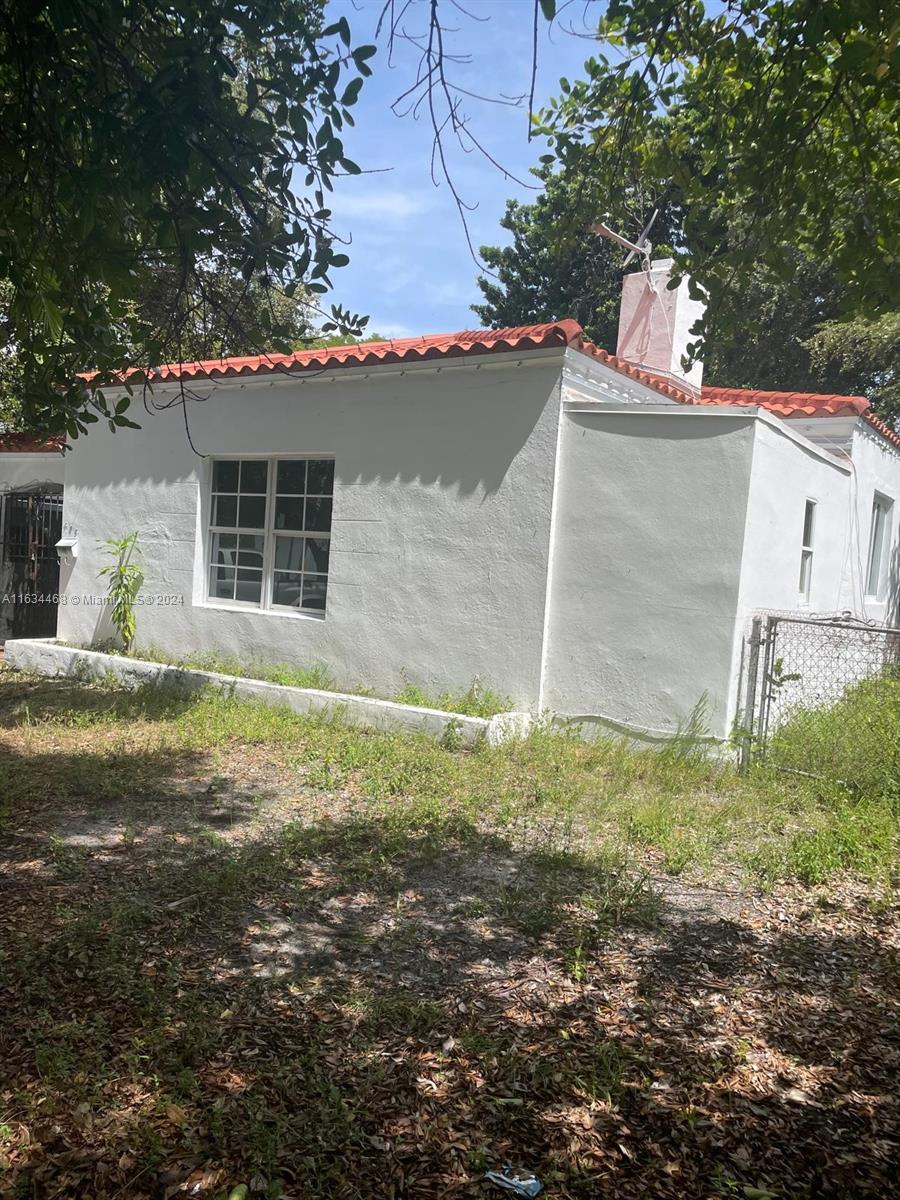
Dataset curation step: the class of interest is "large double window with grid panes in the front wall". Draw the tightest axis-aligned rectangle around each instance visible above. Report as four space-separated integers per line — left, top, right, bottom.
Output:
208 458 335 614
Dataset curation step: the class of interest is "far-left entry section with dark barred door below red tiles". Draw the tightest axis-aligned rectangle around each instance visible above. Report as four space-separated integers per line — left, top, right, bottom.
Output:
0 431 65 643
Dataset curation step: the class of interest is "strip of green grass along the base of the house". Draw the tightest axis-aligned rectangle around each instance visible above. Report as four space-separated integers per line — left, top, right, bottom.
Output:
0 673 900 892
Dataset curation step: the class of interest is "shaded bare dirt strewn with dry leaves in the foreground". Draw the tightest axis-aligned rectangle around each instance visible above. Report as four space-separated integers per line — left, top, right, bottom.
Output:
0 705 900 1200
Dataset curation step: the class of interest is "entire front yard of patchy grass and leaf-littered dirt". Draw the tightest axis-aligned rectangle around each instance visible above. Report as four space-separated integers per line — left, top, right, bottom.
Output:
0 672 895 1200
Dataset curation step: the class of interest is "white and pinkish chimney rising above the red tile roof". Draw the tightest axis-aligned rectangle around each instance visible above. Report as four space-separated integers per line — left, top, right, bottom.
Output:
616 258 706 389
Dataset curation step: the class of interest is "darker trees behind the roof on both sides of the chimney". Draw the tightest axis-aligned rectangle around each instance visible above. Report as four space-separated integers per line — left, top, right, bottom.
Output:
473 168 900 420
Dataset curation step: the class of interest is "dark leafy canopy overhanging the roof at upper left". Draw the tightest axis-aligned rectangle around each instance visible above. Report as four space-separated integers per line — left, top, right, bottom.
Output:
0 0 374 436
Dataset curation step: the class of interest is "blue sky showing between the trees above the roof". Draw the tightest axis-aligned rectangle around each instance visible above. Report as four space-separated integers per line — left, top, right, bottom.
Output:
326 0 602 337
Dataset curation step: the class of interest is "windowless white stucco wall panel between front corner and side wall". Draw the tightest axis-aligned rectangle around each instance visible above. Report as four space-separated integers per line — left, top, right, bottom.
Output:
544 406 755 737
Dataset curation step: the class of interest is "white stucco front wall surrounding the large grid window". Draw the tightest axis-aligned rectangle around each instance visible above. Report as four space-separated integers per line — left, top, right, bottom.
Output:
59 354 562 708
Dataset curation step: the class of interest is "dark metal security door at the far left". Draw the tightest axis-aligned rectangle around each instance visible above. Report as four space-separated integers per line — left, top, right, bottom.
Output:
0 491 62 641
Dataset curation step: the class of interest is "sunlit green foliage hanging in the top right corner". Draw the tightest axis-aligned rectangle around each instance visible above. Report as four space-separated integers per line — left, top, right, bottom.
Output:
539 0 900 350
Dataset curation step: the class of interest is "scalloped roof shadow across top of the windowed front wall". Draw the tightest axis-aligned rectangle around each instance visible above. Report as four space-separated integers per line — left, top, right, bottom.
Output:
68 368 558 494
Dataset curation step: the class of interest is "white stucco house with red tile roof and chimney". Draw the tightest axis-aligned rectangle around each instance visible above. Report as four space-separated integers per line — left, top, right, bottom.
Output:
40 266 900 737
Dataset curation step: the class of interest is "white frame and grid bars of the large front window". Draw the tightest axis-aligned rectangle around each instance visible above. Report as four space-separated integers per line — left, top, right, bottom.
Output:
203 451 335 620
